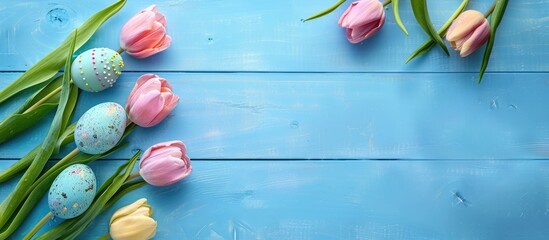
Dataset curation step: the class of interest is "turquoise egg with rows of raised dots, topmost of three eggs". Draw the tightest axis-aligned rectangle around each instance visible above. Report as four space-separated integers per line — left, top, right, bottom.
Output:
71 48 124 92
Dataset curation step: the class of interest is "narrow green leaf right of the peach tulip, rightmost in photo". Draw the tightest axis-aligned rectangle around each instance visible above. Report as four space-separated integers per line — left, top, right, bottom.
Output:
478 0 508 83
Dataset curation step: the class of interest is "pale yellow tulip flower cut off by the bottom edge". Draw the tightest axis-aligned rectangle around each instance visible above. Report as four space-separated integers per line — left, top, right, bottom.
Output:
109 198 156 240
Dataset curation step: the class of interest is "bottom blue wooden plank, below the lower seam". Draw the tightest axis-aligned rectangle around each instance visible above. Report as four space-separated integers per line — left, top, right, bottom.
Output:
0 160 549 239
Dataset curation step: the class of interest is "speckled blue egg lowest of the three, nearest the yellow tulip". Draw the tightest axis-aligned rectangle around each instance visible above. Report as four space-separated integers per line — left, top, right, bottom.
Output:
48 164 97 219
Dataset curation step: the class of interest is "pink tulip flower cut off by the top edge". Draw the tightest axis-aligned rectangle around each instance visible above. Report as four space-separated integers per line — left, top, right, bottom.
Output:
338 0 385 43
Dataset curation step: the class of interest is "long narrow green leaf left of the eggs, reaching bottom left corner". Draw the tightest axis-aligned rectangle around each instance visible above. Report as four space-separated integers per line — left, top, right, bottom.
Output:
0 30 78 236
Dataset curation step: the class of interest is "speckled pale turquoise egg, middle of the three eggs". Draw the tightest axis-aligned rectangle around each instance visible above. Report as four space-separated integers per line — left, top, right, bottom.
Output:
74 102 126 154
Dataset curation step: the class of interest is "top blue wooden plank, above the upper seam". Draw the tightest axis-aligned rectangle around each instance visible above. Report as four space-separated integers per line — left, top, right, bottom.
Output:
0 0 549 72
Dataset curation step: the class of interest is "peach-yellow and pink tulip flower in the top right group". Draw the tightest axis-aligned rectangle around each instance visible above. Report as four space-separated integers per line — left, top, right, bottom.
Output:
446 10 490 57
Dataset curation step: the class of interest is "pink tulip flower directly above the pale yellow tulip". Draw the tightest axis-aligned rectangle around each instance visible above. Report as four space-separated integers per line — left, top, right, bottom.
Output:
139 141 192 186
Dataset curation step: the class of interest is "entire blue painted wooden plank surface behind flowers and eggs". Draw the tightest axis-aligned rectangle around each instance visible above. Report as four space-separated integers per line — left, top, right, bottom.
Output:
0 0 549 239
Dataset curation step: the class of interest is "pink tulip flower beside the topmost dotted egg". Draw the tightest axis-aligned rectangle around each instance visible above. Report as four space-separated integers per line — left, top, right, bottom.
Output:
120 5 172 58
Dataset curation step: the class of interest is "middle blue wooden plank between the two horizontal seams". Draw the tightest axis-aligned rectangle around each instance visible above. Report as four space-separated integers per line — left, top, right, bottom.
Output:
0 73 549 159
